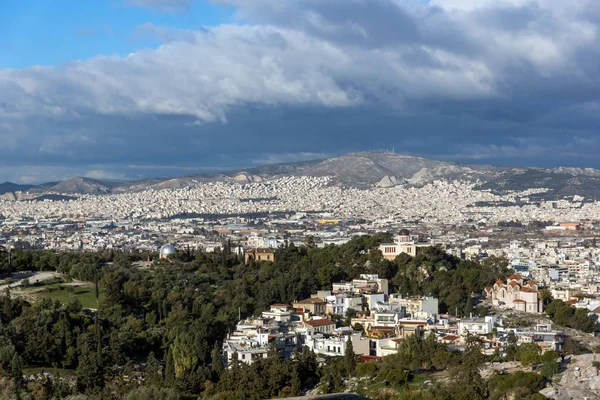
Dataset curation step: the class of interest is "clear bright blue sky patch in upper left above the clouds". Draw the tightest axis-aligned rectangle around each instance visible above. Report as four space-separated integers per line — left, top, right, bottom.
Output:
0 0 232 68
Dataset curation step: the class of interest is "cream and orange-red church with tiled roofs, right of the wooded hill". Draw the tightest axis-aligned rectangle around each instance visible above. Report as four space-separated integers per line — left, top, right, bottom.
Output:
485 275 544 313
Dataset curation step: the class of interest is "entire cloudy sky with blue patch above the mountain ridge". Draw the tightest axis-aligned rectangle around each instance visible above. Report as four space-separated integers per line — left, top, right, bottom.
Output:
0 0 600 183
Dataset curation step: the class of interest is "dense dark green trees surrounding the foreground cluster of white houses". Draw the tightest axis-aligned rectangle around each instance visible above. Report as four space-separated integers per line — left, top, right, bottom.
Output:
0 234 548 399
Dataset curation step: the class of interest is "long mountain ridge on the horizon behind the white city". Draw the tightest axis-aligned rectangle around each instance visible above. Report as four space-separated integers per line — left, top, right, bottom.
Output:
9 151 600 199
